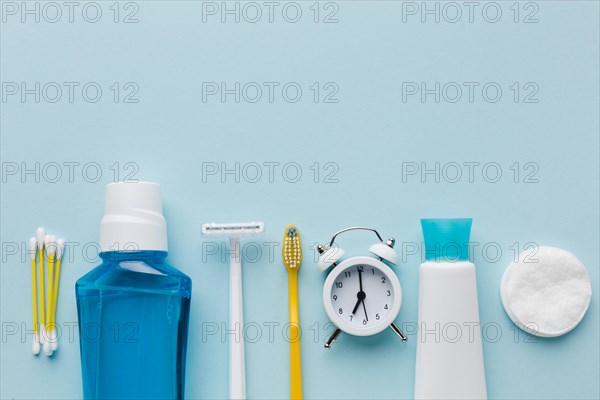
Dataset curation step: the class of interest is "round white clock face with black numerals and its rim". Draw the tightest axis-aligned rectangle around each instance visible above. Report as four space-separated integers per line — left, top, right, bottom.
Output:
323 257 402 336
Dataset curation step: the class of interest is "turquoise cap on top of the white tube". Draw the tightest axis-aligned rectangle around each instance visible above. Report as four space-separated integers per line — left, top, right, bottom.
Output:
421 218 473 261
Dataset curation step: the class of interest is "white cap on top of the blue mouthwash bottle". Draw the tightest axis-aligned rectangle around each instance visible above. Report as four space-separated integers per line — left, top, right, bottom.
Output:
100 182 167 252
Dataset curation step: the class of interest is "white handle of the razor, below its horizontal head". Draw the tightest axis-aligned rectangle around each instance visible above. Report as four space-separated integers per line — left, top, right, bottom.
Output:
229 237 246 400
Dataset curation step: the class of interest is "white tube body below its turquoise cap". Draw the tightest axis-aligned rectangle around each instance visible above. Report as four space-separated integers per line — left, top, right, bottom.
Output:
415 261 487 399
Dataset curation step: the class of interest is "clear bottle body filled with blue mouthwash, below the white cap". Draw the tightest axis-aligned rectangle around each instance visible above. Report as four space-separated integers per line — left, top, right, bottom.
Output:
76 251 191 400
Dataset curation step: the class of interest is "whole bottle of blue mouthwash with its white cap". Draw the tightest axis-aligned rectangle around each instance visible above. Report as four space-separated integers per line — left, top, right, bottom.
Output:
75 182 192 399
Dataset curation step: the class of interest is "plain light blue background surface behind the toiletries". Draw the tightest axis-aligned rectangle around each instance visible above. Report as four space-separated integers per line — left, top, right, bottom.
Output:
0 1 600 399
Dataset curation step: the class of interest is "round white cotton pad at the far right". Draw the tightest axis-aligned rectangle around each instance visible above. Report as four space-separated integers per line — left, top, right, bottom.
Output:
500 246 592 337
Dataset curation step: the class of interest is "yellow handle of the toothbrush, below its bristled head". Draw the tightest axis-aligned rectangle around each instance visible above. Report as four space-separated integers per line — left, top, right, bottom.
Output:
288 269 302 399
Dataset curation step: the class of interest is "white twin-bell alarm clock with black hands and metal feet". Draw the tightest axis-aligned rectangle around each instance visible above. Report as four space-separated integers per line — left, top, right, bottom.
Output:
317 226 407 349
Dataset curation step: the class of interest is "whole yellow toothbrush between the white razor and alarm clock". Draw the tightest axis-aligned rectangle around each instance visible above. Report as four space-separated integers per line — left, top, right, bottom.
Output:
281 224 302 399
